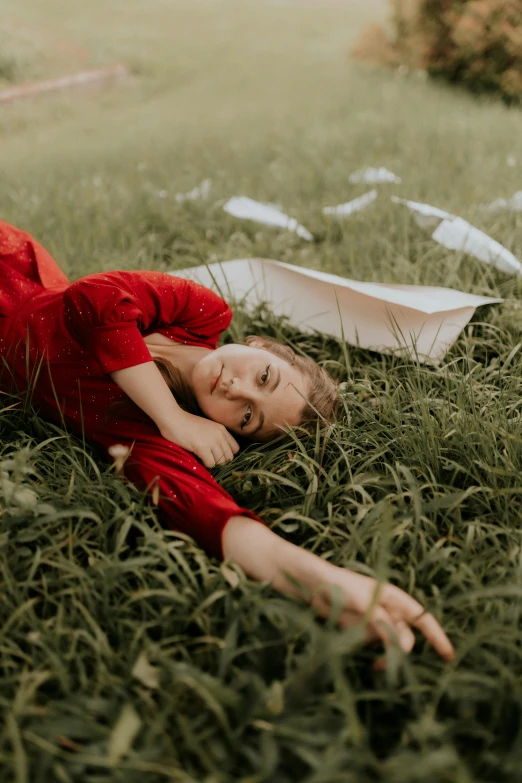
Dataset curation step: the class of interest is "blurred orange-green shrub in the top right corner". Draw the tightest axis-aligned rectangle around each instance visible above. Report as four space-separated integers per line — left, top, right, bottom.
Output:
352 0 522 101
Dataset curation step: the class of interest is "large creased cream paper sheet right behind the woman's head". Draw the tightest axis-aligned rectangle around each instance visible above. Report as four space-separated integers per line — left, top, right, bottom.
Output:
170 258 502 364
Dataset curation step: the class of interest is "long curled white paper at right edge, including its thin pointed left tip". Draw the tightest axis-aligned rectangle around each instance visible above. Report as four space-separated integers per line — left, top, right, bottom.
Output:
392 196 522 275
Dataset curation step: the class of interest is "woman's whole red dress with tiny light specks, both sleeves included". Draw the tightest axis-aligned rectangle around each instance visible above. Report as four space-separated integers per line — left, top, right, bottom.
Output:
0 221 258 556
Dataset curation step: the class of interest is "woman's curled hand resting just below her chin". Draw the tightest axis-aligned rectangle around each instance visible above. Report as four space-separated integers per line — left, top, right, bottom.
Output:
160 409 239 468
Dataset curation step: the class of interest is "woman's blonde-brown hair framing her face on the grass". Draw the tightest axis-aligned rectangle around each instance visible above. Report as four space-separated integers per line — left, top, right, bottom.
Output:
154 335 338 437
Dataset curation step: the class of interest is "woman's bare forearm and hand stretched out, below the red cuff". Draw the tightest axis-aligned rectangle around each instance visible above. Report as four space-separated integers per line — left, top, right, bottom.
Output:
222 516 454 661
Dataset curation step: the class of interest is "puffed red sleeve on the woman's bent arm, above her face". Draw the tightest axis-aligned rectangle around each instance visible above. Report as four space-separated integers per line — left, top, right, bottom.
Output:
63 272 232 373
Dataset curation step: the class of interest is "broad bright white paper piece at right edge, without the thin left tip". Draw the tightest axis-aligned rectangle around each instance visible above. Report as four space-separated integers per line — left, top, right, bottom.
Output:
432 218 522 275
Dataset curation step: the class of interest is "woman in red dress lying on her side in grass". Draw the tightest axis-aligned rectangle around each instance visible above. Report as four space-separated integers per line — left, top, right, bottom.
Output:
0 222 453 659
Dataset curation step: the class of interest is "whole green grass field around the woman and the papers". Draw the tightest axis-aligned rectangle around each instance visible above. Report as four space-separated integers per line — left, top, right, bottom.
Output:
0 0 522 783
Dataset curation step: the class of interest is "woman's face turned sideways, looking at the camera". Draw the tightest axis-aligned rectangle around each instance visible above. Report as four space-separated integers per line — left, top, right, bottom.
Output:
192 344 308 440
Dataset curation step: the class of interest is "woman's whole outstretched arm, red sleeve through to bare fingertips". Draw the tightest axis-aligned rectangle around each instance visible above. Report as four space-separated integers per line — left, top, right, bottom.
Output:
102 432 453 660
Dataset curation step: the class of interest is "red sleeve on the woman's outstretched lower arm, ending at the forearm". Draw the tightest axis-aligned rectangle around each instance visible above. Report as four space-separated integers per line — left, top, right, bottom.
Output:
104 432 262 557
